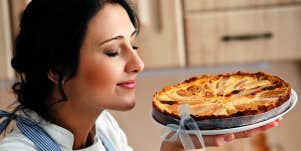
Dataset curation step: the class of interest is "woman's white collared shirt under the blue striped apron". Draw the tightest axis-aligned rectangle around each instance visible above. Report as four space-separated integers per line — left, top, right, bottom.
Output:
0 111 133 151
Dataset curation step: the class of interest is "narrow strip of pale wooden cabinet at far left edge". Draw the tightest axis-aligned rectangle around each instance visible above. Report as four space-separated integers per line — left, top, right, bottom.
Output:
0 0 14 80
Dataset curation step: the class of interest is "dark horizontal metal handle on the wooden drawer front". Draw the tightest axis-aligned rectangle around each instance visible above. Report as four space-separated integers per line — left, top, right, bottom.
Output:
222 32 273 42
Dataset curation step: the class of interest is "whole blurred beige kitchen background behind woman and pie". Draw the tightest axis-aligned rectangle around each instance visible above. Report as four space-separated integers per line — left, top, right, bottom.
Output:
0 0 301 151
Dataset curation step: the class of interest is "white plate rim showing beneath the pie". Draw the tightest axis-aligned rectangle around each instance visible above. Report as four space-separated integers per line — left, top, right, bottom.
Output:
195 89 298 135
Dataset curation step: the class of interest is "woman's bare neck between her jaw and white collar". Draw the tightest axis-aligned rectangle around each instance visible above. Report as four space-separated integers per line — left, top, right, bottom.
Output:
52 100 101 149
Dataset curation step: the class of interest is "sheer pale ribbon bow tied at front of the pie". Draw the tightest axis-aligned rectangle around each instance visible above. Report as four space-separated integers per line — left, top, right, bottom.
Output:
161 104 206 151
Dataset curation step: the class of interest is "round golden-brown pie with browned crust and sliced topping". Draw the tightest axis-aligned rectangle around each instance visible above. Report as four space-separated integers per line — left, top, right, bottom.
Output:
153 71 291 120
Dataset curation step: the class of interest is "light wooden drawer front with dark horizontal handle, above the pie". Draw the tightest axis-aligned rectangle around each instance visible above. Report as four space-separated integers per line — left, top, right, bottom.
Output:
185 5 301 66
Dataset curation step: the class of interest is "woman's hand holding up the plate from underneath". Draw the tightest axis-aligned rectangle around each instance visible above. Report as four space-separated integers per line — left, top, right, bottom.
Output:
161 118 282 151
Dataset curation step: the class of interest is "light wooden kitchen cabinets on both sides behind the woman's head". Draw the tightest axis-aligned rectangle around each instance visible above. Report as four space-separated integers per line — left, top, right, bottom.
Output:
0 0 301 70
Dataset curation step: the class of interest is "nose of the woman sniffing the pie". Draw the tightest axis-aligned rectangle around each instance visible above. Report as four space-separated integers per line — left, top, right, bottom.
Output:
125 50 144 73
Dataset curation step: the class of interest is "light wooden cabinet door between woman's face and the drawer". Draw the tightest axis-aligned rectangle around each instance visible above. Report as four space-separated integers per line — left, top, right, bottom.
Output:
135 0 185 69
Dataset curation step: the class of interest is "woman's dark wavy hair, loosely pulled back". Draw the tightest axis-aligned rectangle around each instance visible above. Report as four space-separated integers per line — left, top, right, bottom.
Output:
11 0 139 120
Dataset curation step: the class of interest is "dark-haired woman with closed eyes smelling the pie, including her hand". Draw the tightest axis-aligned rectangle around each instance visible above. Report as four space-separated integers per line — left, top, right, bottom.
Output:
0 0 277 151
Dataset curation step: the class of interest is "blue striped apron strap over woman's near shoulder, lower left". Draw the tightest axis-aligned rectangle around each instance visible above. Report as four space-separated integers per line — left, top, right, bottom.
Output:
0 110 62 151
